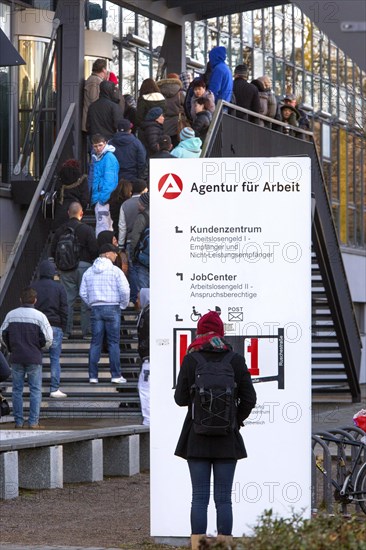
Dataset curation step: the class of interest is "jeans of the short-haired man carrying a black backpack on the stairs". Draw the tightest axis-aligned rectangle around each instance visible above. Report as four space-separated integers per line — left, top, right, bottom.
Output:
60 262 91 336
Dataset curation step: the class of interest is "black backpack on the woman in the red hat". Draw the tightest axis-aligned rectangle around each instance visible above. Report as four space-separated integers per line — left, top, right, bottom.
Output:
191 352 237 436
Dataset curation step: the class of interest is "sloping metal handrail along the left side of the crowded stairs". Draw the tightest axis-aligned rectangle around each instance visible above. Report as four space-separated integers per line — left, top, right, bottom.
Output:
0 103 75 321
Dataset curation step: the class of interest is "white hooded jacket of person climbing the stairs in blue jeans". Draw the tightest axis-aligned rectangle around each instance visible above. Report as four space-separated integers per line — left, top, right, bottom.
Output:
80 256 130 309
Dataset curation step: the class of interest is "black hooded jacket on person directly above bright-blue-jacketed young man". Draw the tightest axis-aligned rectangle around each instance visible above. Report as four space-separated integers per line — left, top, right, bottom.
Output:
86 81 123 141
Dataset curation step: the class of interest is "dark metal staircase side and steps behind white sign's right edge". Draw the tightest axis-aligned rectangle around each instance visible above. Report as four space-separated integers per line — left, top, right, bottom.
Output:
201 102 362 402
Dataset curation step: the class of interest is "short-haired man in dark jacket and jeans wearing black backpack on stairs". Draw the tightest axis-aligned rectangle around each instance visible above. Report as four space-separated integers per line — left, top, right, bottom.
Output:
51 202 98 339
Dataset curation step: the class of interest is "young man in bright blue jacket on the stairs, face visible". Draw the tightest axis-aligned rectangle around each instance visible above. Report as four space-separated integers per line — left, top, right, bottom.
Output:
89 134 119 236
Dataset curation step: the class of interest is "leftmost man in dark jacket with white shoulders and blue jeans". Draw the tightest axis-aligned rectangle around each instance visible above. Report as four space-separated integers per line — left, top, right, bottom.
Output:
0 287 52 430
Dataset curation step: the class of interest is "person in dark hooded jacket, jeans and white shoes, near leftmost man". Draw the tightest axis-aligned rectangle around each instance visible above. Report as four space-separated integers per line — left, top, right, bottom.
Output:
32 260 67 398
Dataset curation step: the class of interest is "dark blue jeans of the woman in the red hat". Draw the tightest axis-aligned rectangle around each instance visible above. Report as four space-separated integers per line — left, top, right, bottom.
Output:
188 458 236 535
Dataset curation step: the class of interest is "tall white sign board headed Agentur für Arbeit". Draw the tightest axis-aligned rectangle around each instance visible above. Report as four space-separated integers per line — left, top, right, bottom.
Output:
150 157 311 537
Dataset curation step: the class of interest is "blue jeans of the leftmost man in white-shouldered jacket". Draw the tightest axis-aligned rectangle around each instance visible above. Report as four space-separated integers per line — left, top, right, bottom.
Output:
11 363 42 426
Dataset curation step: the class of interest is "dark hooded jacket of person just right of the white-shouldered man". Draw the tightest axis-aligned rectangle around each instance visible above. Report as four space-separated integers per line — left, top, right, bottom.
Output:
32 260 67 331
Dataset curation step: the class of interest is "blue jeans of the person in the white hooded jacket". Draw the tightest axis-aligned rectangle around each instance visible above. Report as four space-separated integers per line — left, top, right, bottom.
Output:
89 306 121 378
